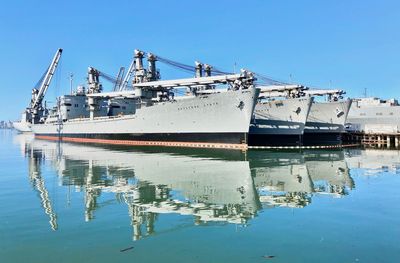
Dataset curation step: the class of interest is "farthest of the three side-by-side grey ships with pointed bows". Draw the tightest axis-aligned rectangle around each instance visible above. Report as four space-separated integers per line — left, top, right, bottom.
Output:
304 90 351 145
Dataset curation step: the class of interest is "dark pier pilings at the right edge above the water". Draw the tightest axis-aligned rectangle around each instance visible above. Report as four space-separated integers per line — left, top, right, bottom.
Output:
343 132 400 148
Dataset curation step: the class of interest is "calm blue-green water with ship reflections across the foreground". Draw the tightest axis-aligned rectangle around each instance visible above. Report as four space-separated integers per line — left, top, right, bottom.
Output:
0 130 400 262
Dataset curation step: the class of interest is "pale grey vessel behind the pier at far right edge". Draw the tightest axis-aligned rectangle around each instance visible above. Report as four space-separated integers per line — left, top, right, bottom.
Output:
346 98 400 134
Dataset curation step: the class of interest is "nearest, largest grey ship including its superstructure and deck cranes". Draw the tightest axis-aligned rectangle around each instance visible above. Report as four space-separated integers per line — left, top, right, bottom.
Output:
31 50 259 149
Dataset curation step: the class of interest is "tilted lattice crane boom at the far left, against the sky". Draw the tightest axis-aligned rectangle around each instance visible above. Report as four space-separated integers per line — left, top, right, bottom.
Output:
30 49 62 123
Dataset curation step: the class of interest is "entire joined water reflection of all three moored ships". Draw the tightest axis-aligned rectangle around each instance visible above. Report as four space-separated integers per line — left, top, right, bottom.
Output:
17 135 354 239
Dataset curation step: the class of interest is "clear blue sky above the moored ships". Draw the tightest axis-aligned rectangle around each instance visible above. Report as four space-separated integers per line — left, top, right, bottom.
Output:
0 0 400 120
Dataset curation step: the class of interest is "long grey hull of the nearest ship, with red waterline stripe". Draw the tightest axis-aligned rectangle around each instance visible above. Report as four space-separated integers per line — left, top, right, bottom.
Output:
32 89 258 149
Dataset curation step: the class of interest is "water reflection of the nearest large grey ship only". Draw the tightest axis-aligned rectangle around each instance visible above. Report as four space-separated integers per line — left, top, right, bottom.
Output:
18 135 260 239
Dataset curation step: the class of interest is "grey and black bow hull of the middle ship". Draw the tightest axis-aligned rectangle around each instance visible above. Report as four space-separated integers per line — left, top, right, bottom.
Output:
249 97 313 146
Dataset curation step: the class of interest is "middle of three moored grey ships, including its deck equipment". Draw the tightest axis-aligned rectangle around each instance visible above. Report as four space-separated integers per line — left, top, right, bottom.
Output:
249 85 313 146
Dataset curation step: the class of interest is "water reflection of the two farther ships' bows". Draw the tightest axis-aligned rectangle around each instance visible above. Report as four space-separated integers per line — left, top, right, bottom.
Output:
248 150 354 207
